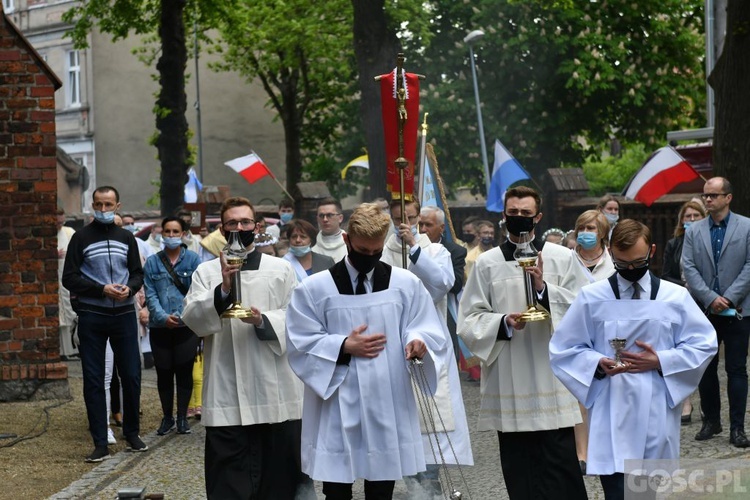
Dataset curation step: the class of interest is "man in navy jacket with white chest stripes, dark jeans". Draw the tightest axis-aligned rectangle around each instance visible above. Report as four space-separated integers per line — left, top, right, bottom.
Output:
62 186 148 462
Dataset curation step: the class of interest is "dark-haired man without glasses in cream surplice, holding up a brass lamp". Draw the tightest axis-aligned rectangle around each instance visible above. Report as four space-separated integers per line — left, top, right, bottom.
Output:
458 186 588 500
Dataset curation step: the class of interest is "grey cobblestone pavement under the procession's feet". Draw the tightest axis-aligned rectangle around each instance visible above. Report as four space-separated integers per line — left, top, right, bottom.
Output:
50 353 750 500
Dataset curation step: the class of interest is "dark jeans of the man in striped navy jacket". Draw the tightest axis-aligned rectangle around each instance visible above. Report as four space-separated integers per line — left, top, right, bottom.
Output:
78 310 141 446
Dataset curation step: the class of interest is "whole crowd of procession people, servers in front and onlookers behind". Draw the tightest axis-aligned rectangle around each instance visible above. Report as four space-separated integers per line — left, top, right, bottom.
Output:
58 177 750 499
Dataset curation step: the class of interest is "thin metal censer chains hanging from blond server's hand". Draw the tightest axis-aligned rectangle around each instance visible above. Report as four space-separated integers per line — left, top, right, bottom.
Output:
409 359 471 500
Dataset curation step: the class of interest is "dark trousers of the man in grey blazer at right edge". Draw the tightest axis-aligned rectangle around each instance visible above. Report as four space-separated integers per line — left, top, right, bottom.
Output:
698 315 750 430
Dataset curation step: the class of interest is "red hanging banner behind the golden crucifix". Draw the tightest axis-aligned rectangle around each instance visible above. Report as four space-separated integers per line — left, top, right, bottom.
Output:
380 69 419 201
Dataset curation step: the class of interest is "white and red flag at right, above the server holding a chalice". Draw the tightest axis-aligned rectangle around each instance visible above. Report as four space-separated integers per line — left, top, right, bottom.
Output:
622 146 700 207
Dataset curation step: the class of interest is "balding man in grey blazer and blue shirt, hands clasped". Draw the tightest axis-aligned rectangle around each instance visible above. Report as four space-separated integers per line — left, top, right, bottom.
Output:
682 177 750 448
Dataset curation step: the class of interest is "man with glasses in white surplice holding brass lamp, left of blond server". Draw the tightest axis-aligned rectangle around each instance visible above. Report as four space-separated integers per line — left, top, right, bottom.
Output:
182 198 302 500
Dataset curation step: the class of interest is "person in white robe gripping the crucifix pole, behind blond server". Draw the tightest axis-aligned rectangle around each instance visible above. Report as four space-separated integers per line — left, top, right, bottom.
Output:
381 200 474 494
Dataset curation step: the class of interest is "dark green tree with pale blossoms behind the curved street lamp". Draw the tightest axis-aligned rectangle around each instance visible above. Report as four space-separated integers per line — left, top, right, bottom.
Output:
422 0 704 192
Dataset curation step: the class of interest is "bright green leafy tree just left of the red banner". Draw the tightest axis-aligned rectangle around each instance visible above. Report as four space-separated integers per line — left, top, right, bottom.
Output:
213 0 361 199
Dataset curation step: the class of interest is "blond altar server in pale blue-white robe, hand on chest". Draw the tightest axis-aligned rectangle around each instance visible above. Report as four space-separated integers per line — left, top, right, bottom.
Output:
287 203 449 499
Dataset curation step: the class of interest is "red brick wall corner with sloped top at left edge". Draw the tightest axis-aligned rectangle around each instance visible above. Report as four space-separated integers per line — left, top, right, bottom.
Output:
0 7 68 401
